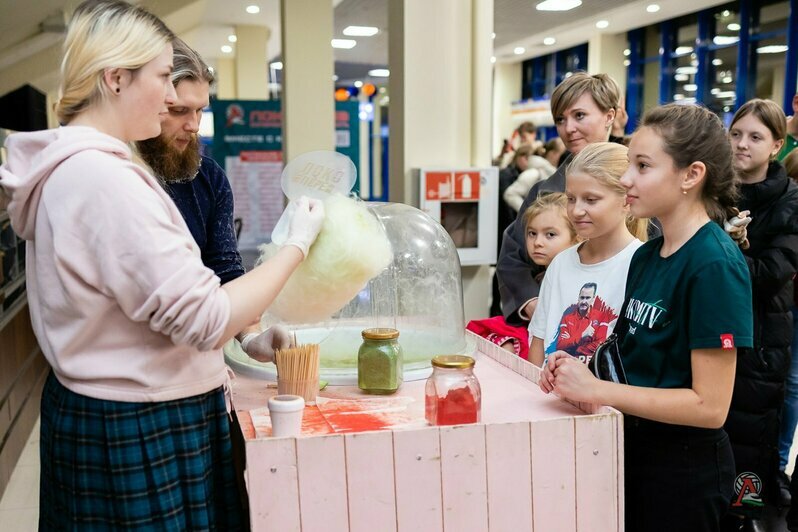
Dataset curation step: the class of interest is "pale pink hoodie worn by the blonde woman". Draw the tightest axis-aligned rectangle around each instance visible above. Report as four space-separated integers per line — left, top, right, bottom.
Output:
0 126 230 402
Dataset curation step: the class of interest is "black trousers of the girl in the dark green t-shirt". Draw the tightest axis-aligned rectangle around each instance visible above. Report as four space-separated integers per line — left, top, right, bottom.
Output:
624 416 734 532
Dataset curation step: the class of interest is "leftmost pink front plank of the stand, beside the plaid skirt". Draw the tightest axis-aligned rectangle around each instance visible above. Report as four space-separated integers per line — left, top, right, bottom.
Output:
245 438 301 532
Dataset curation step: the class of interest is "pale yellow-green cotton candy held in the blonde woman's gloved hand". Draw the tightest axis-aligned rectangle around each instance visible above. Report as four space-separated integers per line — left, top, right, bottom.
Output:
258 194 393 323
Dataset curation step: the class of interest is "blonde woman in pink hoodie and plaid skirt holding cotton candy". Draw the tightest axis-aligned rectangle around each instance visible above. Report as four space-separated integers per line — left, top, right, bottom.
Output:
0 0 324 530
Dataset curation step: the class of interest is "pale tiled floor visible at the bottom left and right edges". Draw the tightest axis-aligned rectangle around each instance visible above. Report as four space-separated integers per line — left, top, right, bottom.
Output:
0 421 798 532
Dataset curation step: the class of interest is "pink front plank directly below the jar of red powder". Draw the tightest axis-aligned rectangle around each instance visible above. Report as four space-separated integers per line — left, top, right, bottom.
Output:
440 425 488 532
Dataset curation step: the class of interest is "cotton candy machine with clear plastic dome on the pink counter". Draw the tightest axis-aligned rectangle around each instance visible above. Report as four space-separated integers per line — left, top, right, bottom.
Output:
224 203 469 385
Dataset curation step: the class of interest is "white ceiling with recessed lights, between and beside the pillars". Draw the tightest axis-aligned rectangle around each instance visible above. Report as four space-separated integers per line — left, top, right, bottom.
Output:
0 0 744 92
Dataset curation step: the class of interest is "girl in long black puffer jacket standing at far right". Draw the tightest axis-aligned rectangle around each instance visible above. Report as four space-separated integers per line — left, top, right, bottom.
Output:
725 99 798 530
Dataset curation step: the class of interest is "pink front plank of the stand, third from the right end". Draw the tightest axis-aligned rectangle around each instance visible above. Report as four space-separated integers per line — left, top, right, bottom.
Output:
485 422 532 532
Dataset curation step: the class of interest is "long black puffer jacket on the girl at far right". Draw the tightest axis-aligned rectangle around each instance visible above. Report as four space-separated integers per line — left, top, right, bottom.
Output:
718 162 798 508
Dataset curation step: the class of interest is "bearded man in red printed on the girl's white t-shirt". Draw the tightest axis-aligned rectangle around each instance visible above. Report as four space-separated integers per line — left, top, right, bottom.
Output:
546 283 618 363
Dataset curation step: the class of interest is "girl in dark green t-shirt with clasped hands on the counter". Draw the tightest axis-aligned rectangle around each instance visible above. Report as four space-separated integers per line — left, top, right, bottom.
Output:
540 104 753 532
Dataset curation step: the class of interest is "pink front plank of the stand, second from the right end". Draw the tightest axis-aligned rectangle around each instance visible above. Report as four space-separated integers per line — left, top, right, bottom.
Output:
531 418 576 532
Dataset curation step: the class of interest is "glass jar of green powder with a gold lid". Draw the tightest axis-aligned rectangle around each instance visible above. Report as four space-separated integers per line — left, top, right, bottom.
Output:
357 328 403 395
